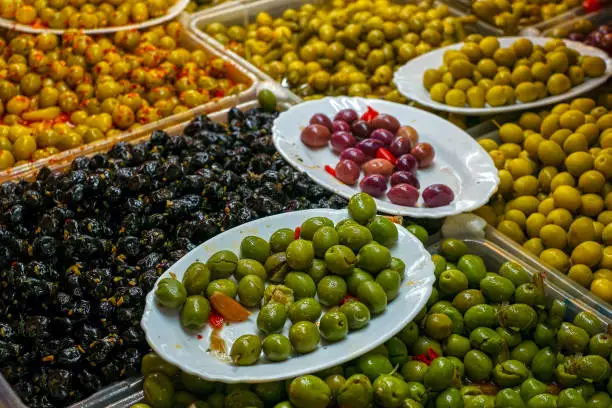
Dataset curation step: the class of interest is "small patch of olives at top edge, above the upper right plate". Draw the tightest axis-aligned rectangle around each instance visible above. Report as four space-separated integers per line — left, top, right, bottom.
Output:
472 0 580 34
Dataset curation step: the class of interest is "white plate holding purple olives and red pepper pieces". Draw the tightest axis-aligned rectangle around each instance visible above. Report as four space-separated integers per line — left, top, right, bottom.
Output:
272 97 499 218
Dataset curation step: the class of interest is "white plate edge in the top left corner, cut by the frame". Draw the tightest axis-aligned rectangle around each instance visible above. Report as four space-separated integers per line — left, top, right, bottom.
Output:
0 0 189 35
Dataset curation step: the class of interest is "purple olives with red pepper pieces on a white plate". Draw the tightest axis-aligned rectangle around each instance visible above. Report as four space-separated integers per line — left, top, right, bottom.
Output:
300 107 455 207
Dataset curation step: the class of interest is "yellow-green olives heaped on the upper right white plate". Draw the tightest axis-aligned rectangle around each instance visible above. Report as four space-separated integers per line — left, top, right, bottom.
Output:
423 37 606 108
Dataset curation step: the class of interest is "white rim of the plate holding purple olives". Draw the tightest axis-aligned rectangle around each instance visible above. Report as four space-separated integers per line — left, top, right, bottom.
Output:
272 96 499 218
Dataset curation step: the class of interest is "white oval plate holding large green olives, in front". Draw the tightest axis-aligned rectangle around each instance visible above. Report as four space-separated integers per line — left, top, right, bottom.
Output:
141 209 435 383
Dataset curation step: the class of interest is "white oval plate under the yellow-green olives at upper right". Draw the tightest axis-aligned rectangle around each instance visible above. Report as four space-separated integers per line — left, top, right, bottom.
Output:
393 37 612 115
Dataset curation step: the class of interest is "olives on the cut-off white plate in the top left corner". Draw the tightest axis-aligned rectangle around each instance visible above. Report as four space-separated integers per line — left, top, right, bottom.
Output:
0 0 175 30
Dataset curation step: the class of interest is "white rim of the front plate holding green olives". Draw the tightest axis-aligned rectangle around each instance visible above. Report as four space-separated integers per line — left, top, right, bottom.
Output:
140 209 435 384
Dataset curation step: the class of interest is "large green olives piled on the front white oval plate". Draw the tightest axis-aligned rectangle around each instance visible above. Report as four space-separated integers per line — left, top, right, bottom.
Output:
155 193 405 365
